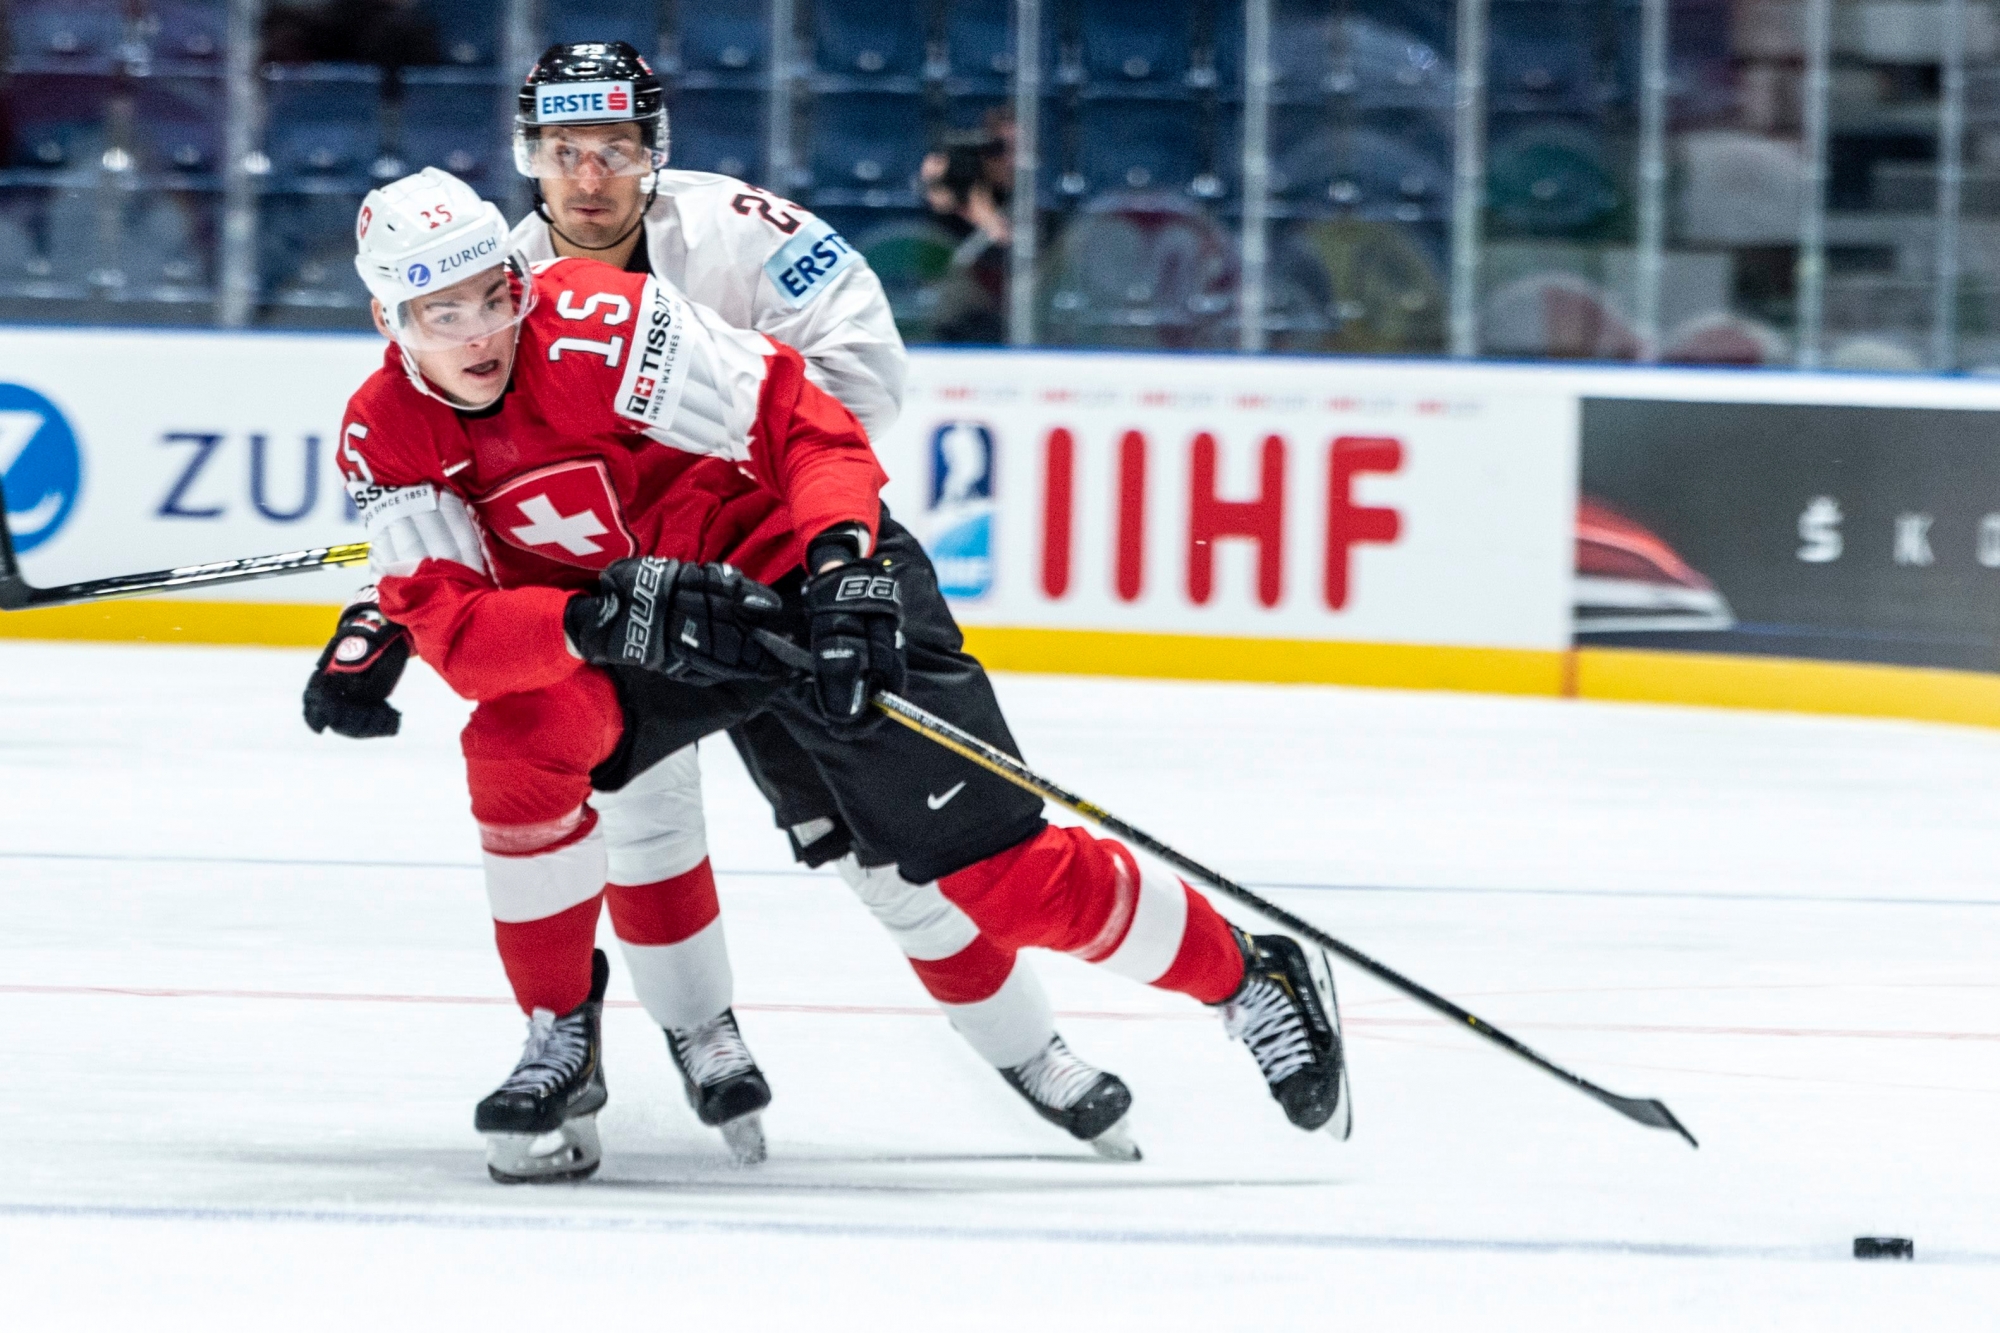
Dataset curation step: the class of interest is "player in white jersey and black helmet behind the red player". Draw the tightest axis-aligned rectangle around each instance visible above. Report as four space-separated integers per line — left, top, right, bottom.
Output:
306 42 1136 1179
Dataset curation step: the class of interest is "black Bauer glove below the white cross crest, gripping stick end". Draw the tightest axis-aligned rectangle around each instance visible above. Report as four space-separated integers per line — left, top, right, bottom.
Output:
562 556 784 685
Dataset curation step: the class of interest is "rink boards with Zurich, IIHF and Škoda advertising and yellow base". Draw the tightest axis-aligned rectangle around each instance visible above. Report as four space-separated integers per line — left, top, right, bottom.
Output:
0 328 2000 723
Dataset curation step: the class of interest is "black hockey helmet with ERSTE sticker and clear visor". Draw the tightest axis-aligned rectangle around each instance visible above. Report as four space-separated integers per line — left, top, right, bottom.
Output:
514 42 668 178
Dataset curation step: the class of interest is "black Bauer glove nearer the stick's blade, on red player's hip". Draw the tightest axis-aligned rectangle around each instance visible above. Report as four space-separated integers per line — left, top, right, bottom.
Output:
806 536 904 727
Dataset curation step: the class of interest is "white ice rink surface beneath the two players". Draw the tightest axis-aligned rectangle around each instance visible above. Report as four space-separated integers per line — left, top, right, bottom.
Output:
0 644 2000 1333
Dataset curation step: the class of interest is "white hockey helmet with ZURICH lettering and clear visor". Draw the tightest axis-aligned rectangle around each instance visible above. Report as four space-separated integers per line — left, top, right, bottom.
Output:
354 166 534 350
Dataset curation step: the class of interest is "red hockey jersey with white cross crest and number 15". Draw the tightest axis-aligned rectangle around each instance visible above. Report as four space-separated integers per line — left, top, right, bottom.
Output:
340 258 886 699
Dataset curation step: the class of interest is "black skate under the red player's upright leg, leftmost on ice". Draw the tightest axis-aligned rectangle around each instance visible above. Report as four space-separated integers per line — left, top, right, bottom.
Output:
472 949 612 1185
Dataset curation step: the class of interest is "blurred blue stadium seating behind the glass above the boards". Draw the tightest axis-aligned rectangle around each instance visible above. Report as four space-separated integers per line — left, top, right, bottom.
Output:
0 0 2000 370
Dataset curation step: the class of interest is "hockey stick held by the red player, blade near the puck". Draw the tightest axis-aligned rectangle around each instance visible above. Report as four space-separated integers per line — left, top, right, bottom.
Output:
756 630 1702 1147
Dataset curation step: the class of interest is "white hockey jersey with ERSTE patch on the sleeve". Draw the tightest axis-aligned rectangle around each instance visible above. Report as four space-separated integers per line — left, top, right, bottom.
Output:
514 170 908 438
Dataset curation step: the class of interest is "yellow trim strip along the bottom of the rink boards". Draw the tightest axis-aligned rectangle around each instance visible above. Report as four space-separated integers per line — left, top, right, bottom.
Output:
0 598 2000 727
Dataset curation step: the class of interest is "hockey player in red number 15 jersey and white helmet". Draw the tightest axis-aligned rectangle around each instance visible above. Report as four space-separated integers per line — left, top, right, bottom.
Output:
340 168 1348 1179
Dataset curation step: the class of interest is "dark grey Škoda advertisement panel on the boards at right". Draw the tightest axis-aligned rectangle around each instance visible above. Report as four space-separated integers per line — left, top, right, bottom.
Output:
1576 398 2000 671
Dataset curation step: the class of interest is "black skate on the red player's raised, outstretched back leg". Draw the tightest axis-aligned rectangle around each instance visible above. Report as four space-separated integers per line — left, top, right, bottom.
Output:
1220 927 1354 1139
